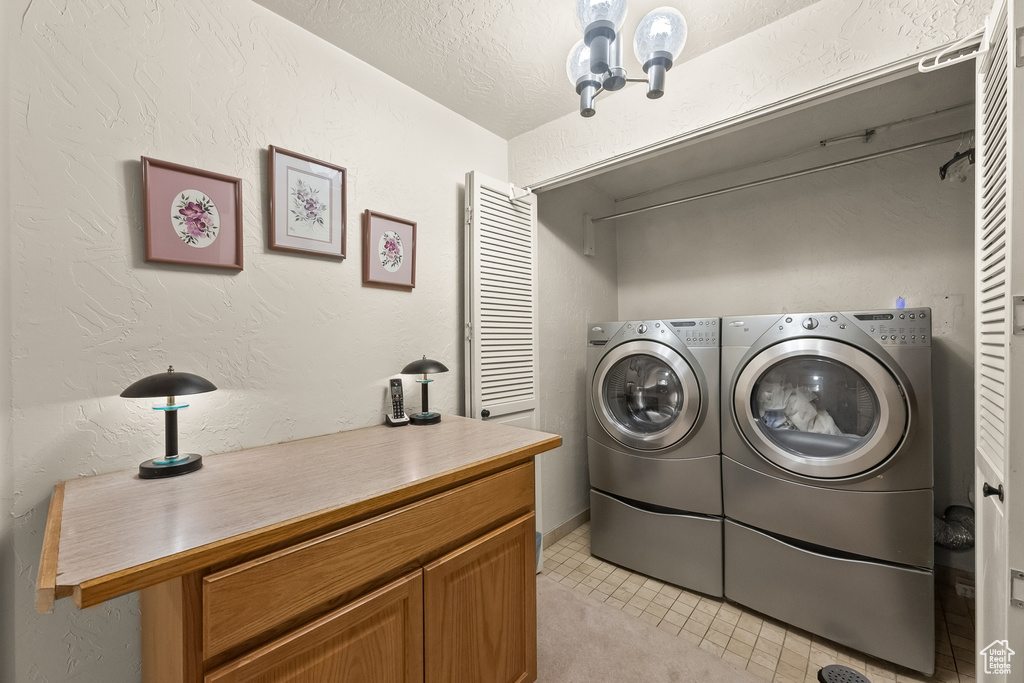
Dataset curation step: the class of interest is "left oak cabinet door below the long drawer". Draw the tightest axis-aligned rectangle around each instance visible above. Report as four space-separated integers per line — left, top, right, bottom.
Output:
205 570 423 683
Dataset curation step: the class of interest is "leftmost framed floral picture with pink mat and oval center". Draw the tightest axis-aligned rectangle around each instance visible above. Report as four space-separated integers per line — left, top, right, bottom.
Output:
142 157 242 270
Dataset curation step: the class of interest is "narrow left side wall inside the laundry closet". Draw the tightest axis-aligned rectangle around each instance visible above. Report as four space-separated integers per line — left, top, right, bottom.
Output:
538 184 618 532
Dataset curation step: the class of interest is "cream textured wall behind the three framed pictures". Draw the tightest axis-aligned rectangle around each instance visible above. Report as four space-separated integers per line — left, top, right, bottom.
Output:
9 0 507 683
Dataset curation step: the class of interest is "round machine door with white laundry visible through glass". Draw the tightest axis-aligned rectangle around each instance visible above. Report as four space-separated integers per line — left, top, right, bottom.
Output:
733 339 908 479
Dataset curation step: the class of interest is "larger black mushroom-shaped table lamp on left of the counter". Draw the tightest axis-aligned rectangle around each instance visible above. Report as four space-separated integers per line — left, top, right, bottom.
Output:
121 368 217 479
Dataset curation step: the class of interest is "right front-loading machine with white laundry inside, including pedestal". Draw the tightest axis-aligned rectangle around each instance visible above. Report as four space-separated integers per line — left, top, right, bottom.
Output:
722 308 935 675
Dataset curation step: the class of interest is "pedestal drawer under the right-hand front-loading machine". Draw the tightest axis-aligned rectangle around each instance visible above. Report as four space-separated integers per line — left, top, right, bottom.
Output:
725 519 935 675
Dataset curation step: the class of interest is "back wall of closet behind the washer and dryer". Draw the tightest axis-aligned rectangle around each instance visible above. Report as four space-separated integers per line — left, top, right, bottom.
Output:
617 141 974 570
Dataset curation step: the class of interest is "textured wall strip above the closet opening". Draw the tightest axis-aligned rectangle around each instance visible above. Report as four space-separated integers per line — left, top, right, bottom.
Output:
509 0 992 185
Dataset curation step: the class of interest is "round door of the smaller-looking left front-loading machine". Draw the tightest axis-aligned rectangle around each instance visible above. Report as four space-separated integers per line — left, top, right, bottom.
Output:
591 340 701 451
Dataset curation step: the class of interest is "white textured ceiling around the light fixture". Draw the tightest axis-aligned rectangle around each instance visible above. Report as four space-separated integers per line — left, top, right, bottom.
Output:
256 0 817 139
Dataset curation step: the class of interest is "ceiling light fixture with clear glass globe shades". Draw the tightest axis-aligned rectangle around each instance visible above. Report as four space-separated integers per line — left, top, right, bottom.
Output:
565 0 686 117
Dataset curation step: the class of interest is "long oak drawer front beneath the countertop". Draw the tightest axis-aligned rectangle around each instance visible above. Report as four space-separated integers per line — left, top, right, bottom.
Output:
203 463 534 658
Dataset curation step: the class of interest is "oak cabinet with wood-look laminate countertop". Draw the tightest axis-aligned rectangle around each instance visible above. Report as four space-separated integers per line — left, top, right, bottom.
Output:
37 417 561 683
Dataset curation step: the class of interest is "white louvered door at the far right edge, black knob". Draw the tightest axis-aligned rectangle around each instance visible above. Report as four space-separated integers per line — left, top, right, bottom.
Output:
975 0 1024 671
